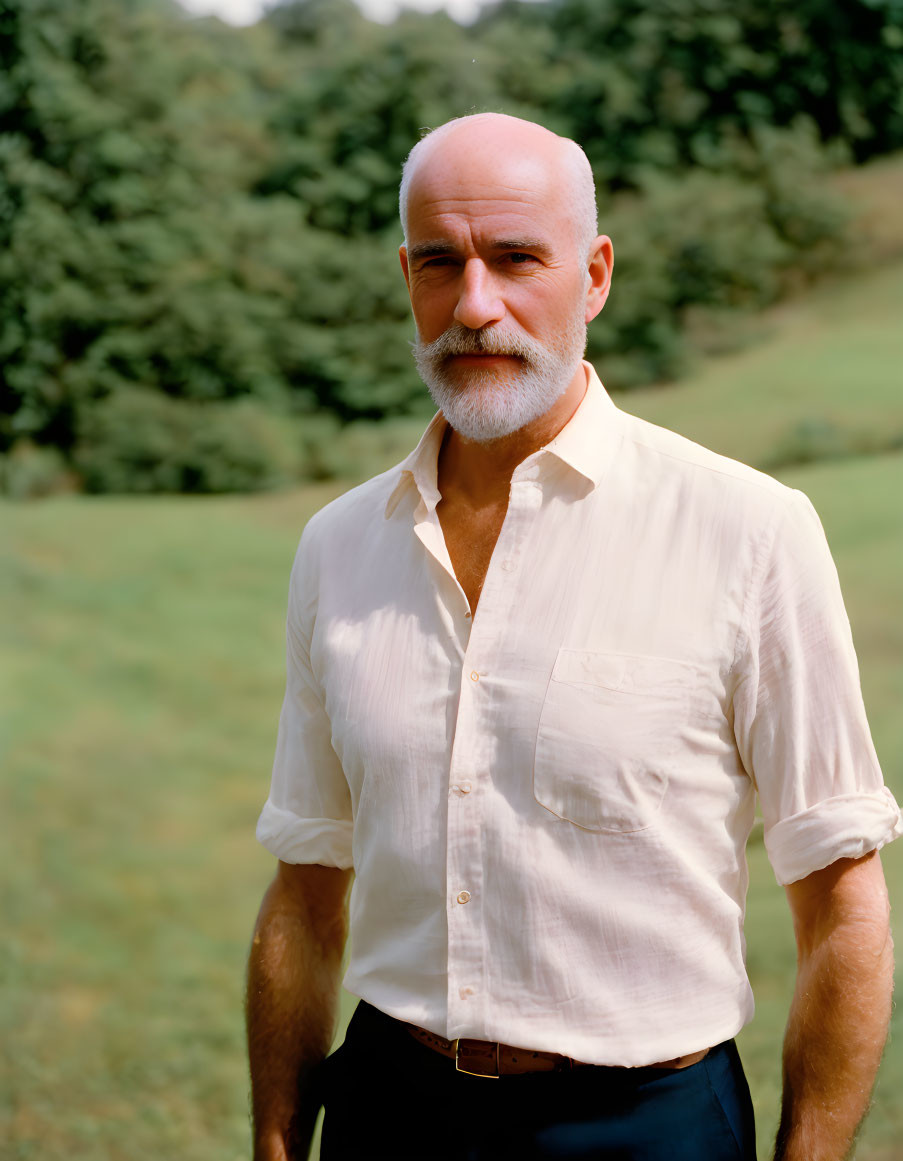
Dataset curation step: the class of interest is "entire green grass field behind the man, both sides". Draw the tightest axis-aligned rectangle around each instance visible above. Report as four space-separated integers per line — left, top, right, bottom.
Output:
0 251 903 1161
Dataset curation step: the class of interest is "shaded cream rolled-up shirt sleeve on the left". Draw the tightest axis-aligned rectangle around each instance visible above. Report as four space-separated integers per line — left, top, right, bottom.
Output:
257 525 353 867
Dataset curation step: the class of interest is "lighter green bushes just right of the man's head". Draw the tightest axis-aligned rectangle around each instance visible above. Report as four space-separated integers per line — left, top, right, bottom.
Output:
588 121 847 389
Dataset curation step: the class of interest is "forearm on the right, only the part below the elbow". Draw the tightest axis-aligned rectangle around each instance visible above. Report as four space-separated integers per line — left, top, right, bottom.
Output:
775 920 894 1161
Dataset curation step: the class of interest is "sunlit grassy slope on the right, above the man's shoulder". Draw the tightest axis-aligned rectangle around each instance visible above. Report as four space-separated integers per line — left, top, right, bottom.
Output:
617 264 903 468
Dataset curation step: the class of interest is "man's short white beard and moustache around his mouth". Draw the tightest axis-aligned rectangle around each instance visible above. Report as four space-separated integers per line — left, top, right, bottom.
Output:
413 302 586 444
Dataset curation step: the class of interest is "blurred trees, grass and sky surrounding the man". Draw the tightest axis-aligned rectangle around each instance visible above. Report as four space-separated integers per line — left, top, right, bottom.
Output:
0 0 903 1161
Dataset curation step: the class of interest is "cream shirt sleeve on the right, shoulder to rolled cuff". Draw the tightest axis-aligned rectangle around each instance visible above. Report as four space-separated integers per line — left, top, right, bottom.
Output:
732 490 903 884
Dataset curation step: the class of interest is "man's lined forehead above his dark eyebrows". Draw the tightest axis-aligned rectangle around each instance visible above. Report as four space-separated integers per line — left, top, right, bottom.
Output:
407 146 570 247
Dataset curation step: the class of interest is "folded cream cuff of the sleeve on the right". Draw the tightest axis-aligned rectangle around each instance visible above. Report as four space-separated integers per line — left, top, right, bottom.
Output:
765 786 903 886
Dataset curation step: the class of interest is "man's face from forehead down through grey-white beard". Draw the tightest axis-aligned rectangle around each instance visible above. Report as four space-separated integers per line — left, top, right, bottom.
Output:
402 142 607 442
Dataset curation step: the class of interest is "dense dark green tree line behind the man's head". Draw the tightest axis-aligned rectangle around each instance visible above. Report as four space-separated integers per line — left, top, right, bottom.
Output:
0 0 903 491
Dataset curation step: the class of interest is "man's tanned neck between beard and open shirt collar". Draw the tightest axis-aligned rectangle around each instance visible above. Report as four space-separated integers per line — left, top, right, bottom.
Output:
439 363 587 507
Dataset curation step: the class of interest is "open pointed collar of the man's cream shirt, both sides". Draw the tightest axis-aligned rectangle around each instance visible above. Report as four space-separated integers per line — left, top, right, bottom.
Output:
385 361 621 520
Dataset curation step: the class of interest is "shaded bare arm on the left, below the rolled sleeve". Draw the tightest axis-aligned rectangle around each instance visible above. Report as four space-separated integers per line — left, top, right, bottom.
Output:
246 863 352 1161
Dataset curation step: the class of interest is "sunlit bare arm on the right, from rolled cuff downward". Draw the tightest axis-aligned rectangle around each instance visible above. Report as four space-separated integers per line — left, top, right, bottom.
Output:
774 851 894 1161
